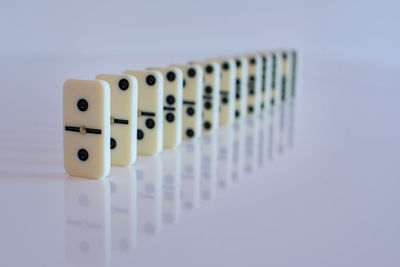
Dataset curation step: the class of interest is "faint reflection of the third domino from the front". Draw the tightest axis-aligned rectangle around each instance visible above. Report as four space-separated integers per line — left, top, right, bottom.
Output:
135 156 162 237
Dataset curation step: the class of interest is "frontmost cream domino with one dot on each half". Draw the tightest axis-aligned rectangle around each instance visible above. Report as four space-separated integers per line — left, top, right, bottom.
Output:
63 80 110 179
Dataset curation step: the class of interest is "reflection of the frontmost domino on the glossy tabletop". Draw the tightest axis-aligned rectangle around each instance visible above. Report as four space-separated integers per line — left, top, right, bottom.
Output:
64 177 111 267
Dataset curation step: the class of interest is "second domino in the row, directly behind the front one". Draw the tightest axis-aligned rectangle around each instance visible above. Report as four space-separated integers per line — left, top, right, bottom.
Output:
96 74 138 167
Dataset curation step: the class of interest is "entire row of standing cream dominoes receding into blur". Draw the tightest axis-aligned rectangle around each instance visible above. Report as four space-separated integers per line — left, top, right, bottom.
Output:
63 50 298 179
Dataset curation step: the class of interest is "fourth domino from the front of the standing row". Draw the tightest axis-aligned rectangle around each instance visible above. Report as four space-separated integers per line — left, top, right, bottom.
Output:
150 68 183 148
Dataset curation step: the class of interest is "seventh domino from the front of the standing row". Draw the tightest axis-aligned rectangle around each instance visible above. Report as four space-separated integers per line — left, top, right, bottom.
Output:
208 58 236 126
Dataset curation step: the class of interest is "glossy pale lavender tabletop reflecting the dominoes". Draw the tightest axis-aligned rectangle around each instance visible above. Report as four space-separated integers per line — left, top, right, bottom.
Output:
0 60 400 266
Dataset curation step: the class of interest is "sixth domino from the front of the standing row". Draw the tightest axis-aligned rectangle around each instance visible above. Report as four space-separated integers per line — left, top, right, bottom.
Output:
189 61 221 133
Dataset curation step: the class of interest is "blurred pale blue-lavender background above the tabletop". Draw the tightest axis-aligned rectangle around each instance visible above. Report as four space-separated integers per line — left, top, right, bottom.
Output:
0 0 400 65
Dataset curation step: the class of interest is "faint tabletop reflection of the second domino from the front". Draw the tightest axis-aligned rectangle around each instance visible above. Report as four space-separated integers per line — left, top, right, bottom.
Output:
109 167 137 255
